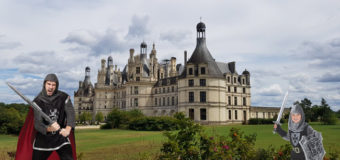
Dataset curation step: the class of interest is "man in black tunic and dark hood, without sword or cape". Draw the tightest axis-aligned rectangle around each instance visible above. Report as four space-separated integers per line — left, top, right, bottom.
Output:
32 74 75 160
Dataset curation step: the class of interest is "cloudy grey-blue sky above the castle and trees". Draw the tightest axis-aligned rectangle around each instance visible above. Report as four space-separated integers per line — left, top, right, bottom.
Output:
0 0 340 111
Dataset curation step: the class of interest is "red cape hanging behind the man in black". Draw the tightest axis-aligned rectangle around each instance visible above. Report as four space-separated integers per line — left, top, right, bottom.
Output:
15 108 77 160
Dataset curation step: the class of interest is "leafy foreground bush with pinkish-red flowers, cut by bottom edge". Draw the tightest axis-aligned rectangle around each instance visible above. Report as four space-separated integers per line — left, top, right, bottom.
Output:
159 115 291 160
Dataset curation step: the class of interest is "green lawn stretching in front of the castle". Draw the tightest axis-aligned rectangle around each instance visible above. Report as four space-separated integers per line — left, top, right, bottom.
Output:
0 123 340 160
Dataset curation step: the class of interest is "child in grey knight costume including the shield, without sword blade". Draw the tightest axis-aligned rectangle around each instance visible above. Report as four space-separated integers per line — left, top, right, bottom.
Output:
274 104 326 160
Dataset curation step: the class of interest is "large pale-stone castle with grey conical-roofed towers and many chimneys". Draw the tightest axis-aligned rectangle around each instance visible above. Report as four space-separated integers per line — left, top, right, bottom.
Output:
74 22 282 124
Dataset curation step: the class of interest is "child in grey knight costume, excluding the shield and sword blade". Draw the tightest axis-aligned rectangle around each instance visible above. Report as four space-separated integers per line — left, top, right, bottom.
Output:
274 104 318 160
